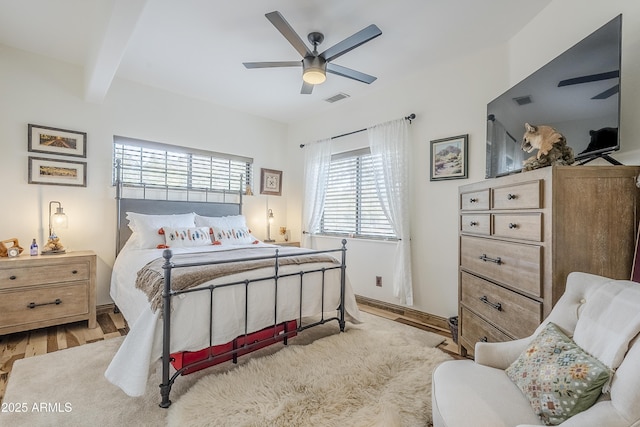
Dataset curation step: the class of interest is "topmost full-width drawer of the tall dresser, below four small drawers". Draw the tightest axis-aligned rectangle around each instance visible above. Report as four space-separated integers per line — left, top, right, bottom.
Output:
460 236 542 297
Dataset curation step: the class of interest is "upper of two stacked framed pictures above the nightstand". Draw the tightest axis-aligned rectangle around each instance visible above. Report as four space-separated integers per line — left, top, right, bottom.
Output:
28 124 87 157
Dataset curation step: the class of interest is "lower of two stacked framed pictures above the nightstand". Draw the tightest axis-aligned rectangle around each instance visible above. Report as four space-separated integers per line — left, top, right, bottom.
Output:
29 157 87 187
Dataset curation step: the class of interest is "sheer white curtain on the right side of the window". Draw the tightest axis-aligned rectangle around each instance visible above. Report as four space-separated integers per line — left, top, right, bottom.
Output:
367 119 413 306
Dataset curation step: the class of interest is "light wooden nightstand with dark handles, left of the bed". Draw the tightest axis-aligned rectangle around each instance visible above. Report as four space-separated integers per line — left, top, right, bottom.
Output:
0 251 97 335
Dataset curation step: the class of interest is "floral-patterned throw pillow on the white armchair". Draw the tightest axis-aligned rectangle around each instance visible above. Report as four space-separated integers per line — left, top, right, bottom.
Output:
506 323 610 425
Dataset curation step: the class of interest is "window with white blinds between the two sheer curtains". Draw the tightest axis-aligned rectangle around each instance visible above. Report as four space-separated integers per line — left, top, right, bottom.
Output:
320 149 396 239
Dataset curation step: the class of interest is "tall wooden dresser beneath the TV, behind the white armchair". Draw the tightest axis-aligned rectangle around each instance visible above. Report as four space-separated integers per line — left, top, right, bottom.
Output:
458 166 640 355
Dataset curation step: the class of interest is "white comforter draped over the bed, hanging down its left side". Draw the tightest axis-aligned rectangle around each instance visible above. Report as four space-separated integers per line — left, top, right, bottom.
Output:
105 244 359 396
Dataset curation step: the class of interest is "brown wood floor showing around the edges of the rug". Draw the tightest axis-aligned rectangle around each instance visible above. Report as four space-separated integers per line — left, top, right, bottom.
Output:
0 304 460 402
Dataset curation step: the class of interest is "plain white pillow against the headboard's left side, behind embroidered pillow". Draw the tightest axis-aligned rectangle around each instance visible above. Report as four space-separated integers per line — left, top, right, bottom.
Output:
127 212 196 249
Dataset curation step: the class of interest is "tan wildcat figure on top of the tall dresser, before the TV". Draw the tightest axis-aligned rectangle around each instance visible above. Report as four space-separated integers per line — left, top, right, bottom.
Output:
521 123 575 172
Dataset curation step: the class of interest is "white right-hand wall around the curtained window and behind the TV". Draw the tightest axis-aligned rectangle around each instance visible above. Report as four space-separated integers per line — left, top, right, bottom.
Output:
288 0 640 317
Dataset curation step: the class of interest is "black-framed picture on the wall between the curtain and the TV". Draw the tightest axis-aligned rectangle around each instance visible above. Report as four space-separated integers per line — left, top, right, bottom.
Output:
431 134 469 181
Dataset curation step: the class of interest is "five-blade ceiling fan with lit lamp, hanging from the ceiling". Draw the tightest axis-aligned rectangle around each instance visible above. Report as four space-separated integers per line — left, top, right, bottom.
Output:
243 11 382 95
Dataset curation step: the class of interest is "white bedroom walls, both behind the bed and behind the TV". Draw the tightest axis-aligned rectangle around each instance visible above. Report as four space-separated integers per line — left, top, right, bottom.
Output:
0 0 640 317
